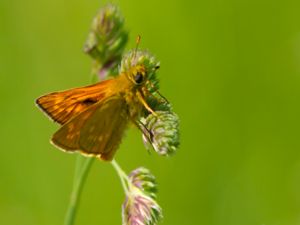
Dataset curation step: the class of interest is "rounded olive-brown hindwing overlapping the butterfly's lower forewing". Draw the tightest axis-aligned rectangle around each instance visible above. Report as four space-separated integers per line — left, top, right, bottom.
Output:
79 97 128 160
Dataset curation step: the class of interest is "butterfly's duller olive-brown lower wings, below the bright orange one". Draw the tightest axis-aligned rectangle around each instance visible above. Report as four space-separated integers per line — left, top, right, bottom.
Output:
52 96 128 160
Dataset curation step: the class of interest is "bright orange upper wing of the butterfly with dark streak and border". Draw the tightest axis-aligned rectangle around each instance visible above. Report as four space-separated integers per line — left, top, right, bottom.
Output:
36 79 114 124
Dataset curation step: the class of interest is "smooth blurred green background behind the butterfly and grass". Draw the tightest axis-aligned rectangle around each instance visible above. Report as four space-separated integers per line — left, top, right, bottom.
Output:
0 0 300 225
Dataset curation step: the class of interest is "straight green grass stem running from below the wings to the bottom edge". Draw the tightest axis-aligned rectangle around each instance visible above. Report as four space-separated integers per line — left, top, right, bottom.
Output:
64 156 95 225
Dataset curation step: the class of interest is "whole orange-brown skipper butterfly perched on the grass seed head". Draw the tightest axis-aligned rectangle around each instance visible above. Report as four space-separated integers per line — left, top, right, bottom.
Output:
36 57 159 161
